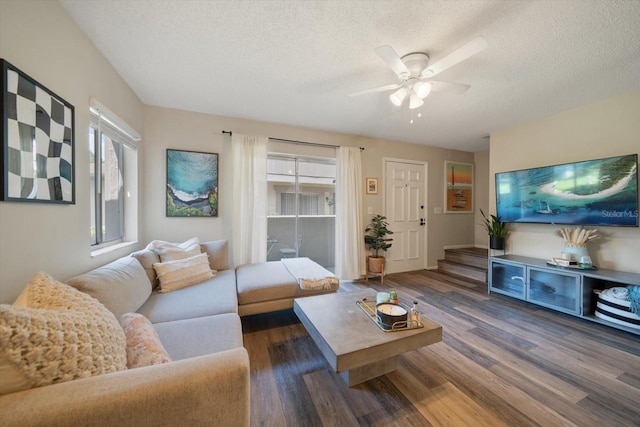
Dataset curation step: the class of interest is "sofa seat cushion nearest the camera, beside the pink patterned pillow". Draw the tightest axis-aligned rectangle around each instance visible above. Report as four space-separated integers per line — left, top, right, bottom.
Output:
153 313 242 360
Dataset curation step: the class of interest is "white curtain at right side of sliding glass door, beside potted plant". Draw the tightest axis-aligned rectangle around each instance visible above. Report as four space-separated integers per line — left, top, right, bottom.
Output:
335 147 365 280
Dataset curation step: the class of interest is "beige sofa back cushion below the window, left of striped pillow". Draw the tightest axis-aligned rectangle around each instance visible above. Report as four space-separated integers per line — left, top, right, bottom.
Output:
67 256 151 318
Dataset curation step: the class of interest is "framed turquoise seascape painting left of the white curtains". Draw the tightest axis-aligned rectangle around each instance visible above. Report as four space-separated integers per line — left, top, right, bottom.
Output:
167 149 218 217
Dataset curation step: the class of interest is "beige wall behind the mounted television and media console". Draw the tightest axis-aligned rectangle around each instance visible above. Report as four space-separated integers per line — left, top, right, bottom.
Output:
489 90 640 273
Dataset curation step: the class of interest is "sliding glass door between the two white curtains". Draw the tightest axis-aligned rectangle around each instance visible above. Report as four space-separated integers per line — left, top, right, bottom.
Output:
267 154 336 269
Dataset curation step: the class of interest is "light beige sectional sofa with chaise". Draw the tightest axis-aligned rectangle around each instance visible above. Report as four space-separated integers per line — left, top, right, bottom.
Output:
0 241 337 427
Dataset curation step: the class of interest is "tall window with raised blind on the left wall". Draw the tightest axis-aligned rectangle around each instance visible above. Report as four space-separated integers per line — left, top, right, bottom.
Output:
89 100 139 246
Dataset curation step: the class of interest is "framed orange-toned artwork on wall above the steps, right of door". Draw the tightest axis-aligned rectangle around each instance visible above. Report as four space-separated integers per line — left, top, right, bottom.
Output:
444 161 473 213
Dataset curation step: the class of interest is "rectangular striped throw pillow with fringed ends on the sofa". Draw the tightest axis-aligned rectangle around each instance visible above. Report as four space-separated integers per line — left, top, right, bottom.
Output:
153 254 213 292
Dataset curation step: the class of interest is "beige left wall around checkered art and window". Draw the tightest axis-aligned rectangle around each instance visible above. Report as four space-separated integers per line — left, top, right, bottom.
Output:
0 0 144 303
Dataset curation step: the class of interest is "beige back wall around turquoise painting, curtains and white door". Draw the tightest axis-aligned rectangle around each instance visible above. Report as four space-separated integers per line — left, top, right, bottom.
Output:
143 106 474 267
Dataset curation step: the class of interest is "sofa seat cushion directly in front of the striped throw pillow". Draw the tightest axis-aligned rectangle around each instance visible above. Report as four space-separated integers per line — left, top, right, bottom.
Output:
138 269 238 322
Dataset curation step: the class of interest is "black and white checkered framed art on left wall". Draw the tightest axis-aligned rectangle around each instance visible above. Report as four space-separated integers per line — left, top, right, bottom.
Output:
0 59 75 204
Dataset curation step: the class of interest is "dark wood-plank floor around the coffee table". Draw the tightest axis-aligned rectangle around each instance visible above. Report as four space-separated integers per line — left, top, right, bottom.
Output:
242 271 640 426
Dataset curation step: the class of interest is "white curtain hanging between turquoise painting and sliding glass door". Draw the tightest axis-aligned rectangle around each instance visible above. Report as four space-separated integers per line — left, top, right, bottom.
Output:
231 133 267 265
